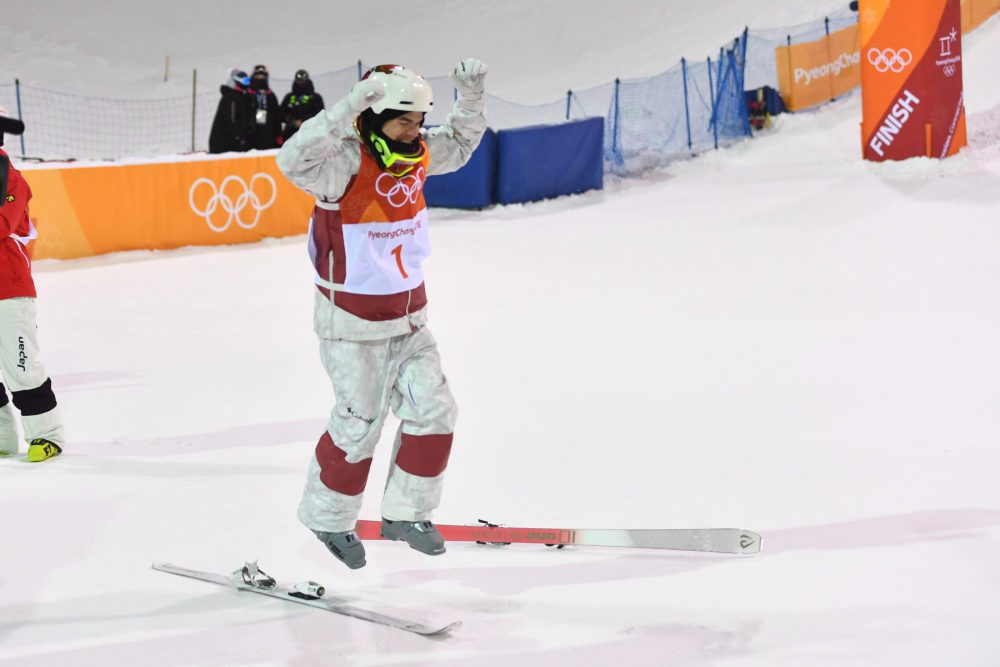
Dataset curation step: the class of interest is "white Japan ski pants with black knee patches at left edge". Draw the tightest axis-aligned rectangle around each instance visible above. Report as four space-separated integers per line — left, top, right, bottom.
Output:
0 297 64 454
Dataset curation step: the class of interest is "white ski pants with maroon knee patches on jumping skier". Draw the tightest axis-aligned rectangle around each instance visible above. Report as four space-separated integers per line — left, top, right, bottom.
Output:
298 327 457 532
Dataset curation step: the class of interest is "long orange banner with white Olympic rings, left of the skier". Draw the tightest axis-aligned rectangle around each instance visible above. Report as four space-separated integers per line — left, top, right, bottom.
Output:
18 152 313 259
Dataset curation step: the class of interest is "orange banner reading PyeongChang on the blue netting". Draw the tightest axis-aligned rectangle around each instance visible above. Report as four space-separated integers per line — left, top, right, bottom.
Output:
775 26 861 111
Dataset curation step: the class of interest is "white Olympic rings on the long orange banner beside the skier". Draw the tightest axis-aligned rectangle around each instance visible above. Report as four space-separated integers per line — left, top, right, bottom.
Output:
188 173 278 234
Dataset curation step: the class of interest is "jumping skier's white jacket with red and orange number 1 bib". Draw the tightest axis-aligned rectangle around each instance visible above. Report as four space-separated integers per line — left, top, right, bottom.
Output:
277 96 486 340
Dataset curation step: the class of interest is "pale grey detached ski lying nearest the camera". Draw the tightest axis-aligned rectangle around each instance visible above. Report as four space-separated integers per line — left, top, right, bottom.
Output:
153 563 461 637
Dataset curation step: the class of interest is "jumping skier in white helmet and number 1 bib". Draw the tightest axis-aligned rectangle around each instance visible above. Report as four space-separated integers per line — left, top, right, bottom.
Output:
277 58 486 569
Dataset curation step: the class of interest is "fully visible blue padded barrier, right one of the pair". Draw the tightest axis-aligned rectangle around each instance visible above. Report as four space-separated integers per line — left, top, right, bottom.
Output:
496 118 605 204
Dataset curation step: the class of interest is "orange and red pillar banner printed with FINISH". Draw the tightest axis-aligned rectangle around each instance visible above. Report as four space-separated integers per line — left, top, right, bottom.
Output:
861 0 966 162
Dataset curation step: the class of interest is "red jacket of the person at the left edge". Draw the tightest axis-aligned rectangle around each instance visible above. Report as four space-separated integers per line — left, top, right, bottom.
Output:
0 149 37 299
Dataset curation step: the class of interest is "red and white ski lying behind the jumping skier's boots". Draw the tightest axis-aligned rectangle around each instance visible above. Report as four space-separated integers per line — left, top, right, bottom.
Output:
355 520 761 554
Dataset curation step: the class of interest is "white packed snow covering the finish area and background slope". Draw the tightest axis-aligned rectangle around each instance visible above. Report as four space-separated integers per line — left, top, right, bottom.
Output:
0 0 1000 667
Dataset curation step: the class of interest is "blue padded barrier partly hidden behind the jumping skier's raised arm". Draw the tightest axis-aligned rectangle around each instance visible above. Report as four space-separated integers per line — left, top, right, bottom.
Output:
424 130 497 208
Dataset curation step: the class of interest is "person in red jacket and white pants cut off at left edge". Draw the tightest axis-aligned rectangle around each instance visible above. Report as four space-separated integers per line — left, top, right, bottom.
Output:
0 109 64 462
